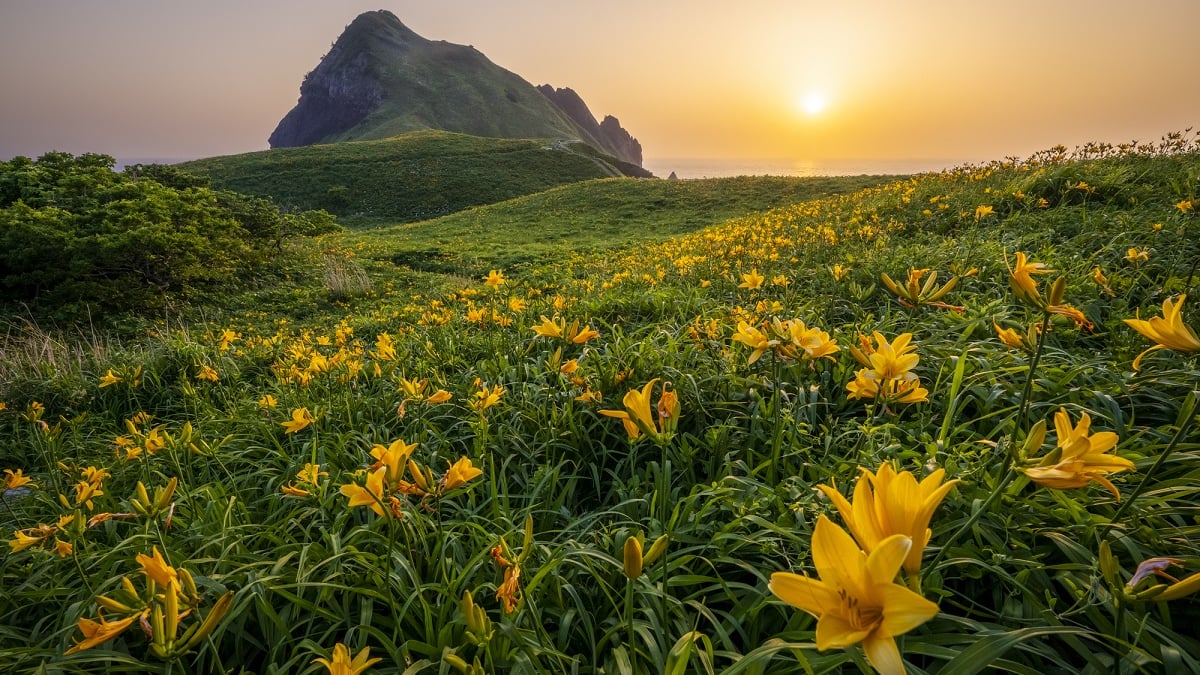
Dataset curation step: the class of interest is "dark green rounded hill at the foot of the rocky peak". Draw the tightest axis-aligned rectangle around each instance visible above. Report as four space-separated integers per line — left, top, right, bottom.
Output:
179 131 649 225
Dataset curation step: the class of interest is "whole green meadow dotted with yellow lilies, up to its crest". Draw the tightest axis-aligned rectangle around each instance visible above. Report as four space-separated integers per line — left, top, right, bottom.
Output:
0 135 1200 675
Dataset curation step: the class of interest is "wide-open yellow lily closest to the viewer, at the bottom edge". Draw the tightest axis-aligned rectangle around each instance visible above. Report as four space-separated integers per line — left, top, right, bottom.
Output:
768 515 938 675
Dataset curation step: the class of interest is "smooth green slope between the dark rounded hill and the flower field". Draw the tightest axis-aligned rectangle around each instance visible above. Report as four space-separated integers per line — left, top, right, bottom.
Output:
347 177 886 276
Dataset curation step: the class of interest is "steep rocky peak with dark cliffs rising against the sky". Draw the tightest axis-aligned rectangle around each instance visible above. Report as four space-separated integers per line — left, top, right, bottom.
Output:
269 10 642 166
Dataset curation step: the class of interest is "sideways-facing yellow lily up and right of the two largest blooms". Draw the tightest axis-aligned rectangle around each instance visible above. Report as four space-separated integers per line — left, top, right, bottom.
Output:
1021 408 1133 500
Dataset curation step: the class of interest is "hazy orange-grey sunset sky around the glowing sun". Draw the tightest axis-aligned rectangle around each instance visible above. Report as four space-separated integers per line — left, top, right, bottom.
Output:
0 0 1200 161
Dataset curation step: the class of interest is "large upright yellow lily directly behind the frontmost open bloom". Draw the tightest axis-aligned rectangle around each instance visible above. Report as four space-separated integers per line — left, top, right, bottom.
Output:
817 462 959 575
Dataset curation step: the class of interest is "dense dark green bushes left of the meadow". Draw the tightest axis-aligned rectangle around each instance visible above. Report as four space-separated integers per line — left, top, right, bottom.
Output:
0 153 337 319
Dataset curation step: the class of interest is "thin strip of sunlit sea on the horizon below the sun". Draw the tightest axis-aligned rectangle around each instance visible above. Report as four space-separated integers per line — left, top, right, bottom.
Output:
642 157 966 178
